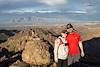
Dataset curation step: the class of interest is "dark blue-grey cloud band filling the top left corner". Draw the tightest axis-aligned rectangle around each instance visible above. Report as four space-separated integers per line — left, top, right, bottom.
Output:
0 0 48 12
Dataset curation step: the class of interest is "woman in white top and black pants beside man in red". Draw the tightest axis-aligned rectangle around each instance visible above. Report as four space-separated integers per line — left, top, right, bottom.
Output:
54 31 68 67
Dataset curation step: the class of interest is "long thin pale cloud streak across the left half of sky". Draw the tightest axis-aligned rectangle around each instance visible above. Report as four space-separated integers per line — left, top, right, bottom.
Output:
2 8 60 14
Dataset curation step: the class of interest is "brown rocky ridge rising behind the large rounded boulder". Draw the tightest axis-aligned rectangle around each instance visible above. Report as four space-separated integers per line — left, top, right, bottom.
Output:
1 28 55 52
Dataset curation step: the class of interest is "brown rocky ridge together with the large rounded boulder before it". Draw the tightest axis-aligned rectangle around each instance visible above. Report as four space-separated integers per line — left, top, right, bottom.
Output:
1 28 56 65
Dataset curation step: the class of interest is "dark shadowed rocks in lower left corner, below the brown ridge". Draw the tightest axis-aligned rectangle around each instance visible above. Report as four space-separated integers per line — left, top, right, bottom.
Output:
0 48 21 67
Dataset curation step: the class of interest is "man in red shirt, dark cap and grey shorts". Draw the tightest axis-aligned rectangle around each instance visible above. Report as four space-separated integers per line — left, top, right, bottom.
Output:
66 24 84 65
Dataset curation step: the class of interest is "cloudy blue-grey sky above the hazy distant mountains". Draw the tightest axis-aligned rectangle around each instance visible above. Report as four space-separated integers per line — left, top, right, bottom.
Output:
0 0 100 22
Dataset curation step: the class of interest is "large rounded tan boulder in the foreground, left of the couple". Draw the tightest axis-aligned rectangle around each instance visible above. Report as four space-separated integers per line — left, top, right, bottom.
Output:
22 40 51 65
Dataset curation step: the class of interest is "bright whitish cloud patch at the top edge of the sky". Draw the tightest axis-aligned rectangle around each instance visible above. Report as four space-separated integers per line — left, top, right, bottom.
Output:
40 0 68 6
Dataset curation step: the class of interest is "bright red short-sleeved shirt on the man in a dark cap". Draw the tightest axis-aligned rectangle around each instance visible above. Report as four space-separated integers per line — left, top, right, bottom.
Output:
67 32 80 55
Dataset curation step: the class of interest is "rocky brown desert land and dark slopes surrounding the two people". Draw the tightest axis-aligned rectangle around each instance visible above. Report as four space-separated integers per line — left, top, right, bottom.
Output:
0 23 100 67
